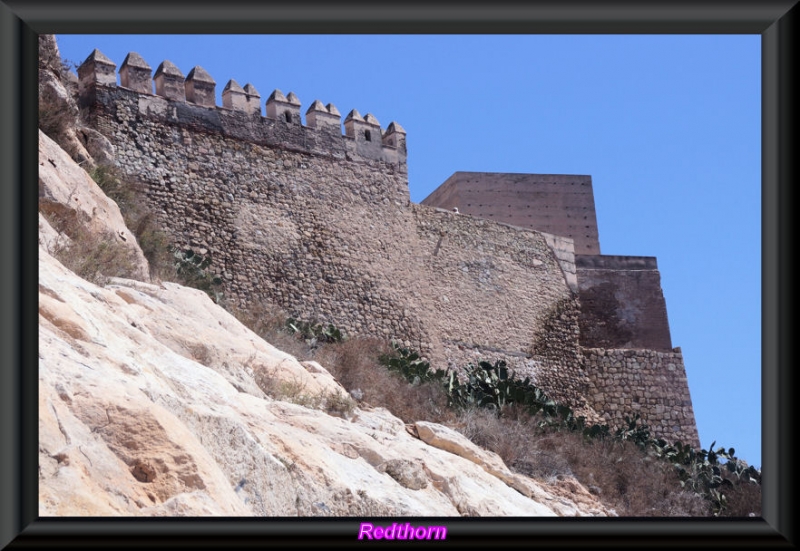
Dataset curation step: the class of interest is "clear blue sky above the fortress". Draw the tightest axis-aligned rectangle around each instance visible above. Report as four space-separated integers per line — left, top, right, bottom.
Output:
51 35 761 467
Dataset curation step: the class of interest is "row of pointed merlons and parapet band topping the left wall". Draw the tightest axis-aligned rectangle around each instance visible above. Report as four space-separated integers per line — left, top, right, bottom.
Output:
78 49 407 166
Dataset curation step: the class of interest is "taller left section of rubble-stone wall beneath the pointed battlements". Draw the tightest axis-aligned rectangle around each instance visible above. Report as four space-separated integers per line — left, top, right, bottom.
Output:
92 79 428 345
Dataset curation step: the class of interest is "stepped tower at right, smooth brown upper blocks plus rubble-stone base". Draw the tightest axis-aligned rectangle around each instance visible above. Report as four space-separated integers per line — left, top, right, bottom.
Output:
422 172 697 443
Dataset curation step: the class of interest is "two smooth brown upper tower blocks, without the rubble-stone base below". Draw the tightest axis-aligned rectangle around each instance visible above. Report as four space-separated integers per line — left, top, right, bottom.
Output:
422 172 672 351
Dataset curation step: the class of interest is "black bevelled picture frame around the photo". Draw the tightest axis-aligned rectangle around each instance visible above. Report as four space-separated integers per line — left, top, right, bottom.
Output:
0 0 800 548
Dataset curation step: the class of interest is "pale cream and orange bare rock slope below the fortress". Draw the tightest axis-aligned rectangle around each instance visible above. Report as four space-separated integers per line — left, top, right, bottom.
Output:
39 39 613 516
